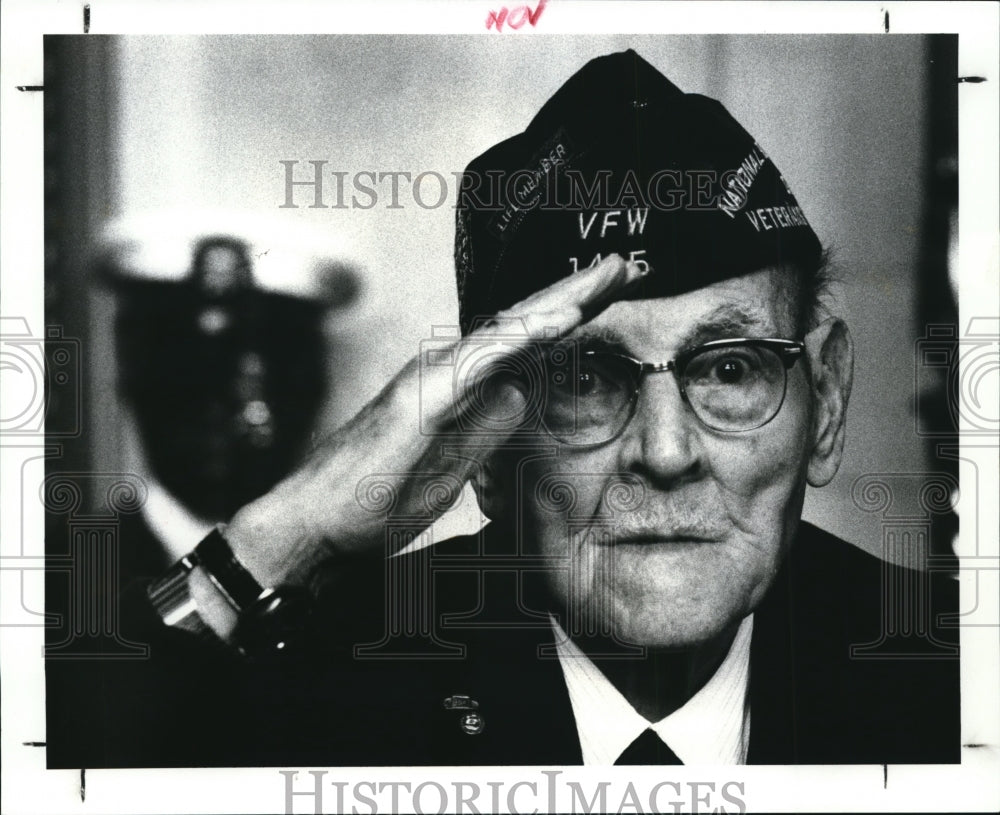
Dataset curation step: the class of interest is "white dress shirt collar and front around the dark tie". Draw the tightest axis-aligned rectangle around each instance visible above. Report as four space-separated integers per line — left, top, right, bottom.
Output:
552 614 753 765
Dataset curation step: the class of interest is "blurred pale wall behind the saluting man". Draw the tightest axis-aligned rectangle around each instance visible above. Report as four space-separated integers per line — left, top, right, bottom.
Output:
74 36 941 552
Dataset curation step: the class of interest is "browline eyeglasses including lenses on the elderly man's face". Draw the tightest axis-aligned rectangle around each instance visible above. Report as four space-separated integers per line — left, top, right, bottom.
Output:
539 338 805 447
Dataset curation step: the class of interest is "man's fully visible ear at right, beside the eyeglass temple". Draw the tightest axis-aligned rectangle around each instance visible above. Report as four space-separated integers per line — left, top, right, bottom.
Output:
805 317 854 487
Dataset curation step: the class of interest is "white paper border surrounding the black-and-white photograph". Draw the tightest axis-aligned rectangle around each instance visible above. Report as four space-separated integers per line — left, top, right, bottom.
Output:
0 0 1000 815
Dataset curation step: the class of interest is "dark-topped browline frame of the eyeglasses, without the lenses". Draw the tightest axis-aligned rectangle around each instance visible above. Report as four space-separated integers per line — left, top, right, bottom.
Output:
546 337 806 450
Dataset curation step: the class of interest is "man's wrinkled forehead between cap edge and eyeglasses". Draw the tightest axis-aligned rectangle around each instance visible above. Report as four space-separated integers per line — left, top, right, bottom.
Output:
571 269 795 358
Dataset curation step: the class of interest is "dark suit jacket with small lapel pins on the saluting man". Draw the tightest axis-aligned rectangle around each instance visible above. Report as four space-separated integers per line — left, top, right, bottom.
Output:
48 524 959 767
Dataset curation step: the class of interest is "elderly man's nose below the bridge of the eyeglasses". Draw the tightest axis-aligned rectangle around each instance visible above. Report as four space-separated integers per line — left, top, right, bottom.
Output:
621 372 703 486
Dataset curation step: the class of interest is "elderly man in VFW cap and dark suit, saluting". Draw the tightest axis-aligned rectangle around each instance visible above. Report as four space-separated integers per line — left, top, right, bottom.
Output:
64 51 959 766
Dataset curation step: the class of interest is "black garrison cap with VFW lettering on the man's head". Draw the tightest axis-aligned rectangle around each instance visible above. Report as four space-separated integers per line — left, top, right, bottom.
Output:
455 50 822 333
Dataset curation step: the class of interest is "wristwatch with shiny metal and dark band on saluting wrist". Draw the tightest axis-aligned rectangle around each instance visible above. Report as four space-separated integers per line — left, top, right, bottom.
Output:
148 524 311 660
